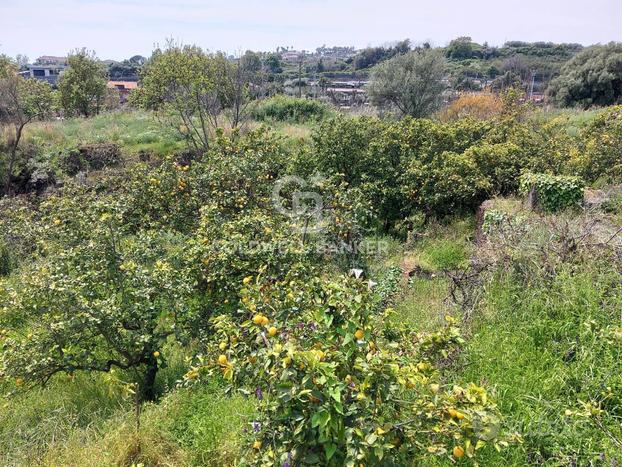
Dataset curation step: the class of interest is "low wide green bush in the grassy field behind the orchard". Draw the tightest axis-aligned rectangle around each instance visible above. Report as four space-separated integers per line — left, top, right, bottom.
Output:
251 95 330 123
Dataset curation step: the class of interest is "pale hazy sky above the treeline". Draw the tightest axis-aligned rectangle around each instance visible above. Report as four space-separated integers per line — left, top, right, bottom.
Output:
0 0 622 59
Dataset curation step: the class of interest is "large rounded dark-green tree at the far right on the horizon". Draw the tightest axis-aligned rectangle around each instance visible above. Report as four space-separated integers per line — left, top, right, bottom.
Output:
549 42 622 108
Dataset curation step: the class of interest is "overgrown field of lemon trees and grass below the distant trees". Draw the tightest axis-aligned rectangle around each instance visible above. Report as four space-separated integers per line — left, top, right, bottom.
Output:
0 104 622 467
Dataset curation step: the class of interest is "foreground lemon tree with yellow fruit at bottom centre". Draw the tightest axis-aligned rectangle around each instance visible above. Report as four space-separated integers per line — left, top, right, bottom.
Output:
186 273 504 465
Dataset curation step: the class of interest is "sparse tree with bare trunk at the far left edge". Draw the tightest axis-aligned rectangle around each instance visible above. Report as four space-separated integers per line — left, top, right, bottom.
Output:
0 57 55 194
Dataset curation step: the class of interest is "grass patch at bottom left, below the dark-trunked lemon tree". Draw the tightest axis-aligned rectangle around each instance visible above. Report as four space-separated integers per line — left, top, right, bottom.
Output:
43 386 254 467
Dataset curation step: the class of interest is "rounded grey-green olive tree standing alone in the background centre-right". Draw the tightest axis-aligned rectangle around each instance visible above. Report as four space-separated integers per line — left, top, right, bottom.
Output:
368 49 446 117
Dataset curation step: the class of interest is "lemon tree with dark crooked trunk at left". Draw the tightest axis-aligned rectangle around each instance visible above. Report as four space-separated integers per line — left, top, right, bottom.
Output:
0 210 195 399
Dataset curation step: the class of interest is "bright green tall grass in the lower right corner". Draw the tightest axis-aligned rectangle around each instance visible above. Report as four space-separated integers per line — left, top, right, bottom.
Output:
459 272 622 465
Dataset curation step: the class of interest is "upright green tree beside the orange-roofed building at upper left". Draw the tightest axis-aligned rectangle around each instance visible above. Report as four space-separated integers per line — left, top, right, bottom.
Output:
58 49 107 117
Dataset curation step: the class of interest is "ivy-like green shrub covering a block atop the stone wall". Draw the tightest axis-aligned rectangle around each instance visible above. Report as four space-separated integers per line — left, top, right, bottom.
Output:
520 173 585 212
